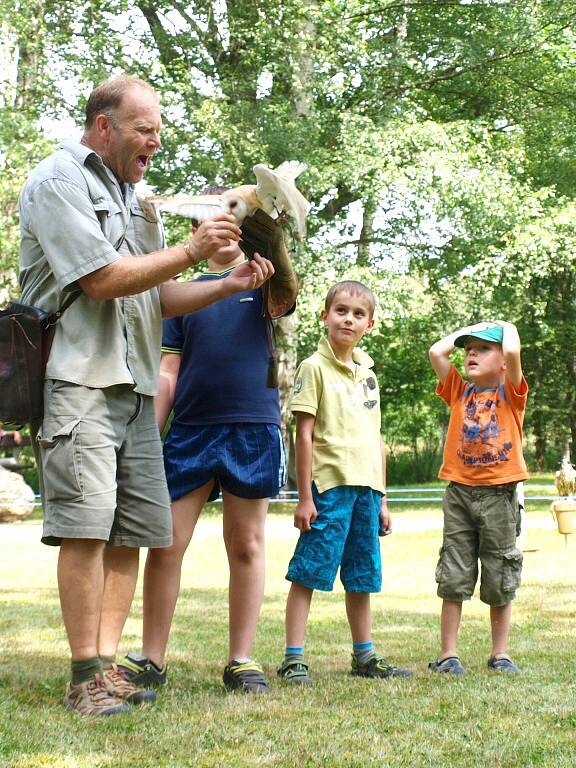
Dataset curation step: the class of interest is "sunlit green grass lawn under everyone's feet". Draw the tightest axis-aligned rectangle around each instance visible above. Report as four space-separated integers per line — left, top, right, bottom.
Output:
0 505 576 768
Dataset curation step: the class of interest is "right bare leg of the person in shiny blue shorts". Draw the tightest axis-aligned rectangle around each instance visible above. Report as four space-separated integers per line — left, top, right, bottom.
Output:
222 491 269 659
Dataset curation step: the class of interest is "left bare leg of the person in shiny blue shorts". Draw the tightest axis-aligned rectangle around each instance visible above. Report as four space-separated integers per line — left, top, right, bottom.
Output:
142 481 214 669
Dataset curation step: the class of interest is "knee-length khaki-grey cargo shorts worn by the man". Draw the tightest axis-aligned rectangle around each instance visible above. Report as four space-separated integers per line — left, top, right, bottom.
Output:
35 379 172 547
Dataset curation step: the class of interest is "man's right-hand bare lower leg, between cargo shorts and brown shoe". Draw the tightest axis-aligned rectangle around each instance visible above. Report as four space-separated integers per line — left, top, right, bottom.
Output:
98 546 140 657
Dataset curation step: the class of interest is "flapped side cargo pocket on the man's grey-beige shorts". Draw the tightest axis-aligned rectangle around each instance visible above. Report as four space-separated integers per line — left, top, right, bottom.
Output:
37 419 84 501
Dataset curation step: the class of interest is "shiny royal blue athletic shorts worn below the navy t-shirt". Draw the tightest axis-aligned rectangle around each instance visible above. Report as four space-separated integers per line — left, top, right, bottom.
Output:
164 424 286 501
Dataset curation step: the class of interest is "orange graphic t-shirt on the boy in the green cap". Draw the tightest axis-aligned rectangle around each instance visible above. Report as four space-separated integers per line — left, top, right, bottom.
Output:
436 366 528 485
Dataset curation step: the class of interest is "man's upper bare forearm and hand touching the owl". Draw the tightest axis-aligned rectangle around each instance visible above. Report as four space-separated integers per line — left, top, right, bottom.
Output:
78 213 240 303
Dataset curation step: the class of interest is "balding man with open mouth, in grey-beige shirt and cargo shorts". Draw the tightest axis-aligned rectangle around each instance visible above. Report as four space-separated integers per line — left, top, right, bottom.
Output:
20 77 274 716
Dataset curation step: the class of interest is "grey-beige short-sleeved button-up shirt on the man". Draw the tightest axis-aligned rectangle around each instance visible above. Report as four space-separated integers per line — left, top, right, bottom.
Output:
20 141 165 395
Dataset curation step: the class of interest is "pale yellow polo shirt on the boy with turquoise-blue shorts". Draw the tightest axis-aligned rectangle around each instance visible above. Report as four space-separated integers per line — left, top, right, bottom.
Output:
290 338 384 493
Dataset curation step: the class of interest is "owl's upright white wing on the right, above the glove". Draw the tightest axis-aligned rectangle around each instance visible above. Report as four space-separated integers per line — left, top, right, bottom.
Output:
253 161 310 239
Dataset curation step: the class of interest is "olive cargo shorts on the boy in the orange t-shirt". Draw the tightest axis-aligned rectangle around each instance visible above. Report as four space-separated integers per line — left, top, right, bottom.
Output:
436 483 522 605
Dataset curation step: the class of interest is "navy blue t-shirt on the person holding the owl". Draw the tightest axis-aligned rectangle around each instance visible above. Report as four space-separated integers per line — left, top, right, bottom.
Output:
162 270 280 426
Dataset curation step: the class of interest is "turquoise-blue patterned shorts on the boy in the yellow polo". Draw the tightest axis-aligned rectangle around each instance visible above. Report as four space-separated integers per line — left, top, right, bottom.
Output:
286 483 382 592
